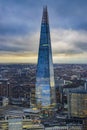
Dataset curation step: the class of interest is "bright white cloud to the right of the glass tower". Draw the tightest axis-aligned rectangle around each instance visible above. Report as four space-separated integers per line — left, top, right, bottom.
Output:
51 29 87 55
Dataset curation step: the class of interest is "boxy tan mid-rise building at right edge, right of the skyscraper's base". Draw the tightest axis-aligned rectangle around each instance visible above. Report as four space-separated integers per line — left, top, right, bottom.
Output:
68 90 87 118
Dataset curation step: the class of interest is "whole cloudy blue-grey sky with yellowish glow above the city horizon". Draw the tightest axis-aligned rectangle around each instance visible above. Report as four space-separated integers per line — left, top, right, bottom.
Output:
0 0 87 63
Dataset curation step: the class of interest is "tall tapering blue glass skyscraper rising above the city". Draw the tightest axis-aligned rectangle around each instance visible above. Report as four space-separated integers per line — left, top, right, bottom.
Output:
35 7 56 107
